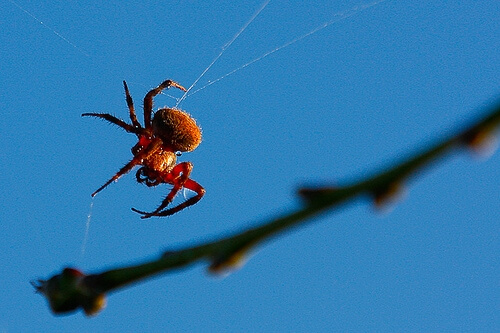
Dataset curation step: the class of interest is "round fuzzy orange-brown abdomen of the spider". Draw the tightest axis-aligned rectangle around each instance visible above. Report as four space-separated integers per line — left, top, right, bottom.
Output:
153 108 201 152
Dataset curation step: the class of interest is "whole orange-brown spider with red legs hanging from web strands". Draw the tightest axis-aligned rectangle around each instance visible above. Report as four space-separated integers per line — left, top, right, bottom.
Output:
82 80 205 219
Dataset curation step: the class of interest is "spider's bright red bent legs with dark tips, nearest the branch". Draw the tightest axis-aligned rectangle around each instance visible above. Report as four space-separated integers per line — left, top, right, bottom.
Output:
132 162 205 219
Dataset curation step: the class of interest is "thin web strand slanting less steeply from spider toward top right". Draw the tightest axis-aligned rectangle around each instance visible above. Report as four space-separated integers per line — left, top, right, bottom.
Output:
188 0 386 96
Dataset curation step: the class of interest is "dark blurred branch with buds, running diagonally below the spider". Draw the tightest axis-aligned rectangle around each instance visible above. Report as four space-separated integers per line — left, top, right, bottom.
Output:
32 99 500 315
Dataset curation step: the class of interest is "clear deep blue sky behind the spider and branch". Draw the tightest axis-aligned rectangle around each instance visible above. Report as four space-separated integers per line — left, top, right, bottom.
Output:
0 0 500 332
